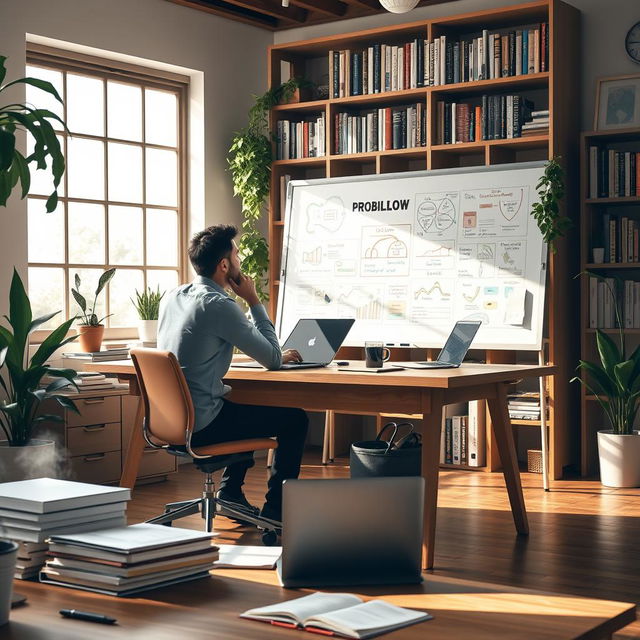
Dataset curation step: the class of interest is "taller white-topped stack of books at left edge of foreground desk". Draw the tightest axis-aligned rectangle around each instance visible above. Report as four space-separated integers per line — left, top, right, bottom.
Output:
0 478 131 580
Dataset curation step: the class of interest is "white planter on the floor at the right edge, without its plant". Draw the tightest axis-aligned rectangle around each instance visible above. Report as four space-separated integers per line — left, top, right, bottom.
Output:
598 429 640 488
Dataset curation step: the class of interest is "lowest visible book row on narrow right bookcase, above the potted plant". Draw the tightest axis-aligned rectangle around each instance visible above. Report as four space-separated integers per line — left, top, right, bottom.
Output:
589 276 640 329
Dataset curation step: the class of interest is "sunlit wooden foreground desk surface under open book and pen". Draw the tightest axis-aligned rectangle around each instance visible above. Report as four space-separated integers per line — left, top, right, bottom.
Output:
8 570 636 640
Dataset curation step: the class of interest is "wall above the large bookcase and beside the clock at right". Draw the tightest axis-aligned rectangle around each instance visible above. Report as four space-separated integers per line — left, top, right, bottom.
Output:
274 0 640 130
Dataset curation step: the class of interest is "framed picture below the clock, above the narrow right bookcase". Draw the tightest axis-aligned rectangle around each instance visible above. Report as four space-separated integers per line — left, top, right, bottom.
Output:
593 74 640 131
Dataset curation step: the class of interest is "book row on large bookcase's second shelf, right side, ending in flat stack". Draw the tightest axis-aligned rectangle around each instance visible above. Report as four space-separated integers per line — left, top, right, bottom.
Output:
436 95 549 144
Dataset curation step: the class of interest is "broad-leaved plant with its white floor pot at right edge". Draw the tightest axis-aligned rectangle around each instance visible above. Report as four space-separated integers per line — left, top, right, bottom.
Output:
572 272 640 487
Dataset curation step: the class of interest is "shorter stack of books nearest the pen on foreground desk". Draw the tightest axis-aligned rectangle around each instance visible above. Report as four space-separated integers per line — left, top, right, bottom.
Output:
40 523 218 596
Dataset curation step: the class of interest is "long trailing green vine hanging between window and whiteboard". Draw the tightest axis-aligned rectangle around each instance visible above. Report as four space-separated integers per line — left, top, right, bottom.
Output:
227 78 310 299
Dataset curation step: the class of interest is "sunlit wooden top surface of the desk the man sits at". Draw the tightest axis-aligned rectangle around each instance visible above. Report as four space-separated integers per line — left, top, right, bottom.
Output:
85 360 556 389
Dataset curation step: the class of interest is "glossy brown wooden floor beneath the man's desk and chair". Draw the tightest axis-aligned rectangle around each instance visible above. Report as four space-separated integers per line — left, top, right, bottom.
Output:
128 451 640 640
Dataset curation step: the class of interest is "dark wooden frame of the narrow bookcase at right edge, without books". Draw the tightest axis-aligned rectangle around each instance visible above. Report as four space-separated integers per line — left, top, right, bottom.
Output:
580 129 640 476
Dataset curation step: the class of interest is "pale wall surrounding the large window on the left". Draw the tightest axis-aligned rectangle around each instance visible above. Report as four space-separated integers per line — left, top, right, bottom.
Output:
0 0 273 314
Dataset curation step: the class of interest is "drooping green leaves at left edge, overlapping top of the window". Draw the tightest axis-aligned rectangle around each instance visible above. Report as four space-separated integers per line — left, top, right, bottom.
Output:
0 56 66 212
